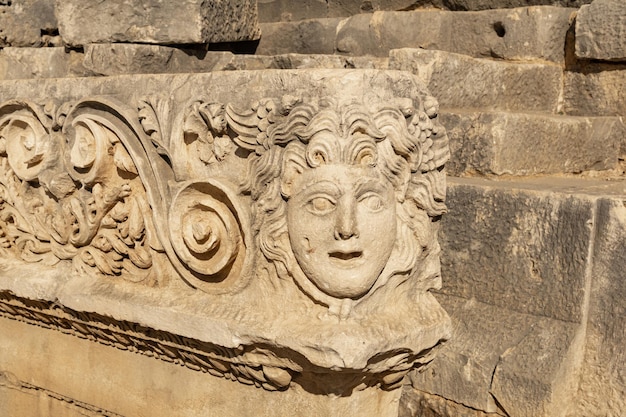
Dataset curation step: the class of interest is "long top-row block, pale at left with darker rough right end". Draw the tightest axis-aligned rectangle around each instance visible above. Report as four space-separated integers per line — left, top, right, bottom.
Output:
56 0 260 45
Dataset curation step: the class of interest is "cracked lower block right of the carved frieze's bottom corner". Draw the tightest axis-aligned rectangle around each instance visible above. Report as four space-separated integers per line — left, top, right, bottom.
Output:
411 295 583 417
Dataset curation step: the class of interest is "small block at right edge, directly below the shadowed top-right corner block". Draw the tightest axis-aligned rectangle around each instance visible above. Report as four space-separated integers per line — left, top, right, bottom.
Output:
563 66 626 116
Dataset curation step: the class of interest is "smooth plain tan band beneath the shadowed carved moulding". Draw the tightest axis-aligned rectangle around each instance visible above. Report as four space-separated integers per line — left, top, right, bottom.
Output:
0 317 400 417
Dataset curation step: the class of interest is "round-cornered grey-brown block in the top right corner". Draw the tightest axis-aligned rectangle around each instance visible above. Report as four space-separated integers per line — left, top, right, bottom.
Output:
576 0 626 61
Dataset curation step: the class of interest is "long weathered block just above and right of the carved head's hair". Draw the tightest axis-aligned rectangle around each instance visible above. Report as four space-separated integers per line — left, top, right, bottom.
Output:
389 49 562 113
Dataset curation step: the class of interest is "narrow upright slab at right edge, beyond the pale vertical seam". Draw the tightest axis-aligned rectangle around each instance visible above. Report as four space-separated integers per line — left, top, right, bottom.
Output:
570 199 626 417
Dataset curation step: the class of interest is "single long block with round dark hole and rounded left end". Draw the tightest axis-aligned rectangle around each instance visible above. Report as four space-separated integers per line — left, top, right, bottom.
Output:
337 7 575 62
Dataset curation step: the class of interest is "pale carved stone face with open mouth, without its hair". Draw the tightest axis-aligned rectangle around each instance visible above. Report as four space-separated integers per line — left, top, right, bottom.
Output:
287 164 396 298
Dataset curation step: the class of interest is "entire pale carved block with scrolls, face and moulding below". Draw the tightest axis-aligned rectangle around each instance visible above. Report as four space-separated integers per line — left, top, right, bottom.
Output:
0 69 450 416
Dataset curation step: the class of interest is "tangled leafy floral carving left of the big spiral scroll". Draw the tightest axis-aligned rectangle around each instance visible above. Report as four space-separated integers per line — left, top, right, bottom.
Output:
0 103 160 281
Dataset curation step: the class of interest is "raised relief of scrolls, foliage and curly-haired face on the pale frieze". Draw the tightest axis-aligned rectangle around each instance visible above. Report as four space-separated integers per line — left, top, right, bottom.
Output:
0 72 449 394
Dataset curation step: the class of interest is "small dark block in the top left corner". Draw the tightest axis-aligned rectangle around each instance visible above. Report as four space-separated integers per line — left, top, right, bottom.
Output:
0 0 59 47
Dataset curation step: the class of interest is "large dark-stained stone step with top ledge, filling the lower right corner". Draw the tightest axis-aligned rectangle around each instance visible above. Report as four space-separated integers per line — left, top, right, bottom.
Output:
412 178 626 417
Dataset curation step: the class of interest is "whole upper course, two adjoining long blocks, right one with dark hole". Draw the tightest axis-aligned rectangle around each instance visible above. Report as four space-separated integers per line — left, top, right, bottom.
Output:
257 6 576 63
